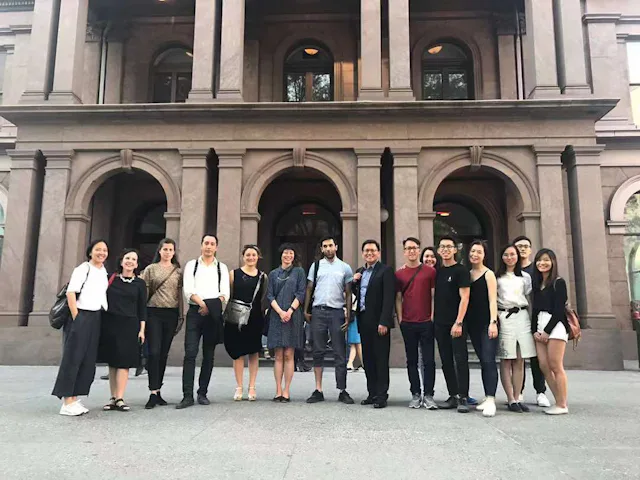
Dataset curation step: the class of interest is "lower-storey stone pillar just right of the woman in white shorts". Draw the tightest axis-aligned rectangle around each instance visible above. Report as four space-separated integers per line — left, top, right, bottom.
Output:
568 146 616 329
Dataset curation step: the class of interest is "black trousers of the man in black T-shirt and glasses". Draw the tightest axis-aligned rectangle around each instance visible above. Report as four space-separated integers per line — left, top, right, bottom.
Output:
435 323 469 398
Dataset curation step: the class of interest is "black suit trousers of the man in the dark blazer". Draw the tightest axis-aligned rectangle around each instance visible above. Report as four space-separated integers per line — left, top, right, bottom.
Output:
359 323 391 402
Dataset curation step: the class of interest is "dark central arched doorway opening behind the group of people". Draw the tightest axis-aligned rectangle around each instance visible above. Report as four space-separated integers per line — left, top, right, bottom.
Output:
258 168 342 269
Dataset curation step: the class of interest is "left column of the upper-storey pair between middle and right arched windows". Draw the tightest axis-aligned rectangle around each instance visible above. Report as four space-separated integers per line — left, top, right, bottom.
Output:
358 0 384 100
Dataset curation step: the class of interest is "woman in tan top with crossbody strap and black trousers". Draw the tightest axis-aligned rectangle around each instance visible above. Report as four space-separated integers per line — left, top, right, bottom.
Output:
140 238 184 409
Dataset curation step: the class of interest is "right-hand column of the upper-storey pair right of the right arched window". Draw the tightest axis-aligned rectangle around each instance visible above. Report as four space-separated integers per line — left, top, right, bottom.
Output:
553 0 591 97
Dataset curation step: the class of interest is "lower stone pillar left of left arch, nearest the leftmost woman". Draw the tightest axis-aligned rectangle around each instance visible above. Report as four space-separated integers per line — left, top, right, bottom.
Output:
29 150 75 326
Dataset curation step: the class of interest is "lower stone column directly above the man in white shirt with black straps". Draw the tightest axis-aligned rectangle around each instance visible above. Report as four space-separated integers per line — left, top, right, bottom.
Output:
176 149 209 263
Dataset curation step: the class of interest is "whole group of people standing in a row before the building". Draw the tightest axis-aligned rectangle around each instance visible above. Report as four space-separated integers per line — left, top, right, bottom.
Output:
53 234 568 417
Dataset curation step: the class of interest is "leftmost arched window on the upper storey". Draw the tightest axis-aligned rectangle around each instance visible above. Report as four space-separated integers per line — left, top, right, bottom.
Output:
152 47 193 103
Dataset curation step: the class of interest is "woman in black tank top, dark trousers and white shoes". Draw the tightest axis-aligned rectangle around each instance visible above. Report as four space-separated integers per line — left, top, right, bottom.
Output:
464 240 498 417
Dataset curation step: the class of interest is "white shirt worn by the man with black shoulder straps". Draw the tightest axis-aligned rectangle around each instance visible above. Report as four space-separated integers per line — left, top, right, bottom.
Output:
183 257 231 305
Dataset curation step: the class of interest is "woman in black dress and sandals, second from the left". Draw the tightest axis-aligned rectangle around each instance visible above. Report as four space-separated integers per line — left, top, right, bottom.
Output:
98 248 147 412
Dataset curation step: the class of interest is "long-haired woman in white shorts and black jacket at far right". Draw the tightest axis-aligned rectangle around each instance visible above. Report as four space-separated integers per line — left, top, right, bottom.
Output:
531 248 569 415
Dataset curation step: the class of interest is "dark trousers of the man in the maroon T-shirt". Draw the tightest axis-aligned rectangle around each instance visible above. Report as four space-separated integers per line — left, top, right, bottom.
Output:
400 322 436 396
